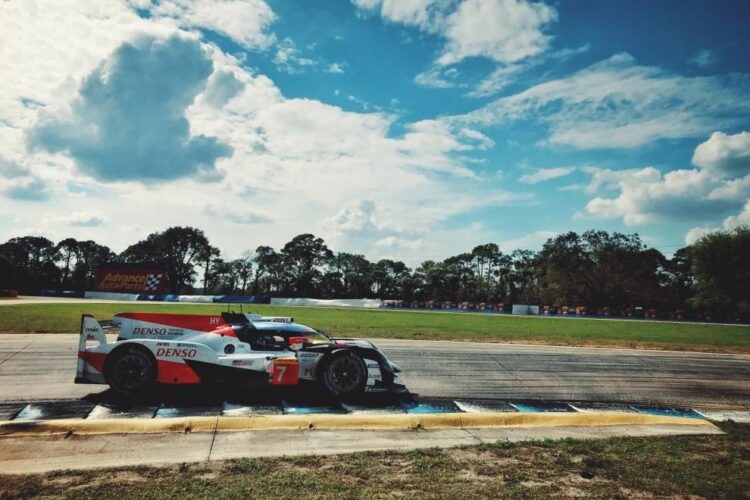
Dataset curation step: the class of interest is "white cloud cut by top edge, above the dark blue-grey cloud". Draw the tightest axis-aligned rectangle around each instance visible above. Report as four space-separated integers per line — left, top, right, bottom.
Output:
130 0 276 49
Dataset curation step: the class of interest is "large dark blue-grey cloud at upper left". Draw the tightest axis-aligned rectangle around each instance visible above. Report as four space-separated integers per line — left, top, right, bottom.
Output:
27 36 232 181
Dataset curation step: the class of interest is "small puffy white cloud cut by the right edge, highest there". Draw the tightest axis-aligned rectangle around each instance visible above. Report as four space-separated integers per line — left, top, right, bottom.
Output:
693 132 750 176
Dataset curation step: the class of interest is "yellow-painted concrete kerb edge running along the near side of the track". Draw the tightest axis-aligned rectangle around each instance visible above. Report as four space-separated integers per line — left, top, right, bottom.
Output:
0 412 715 436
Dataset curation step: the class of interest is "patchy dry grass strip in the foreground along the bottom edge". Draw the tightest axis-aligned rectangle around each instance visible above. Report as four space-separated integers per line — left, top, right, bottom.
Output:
0 423 750 500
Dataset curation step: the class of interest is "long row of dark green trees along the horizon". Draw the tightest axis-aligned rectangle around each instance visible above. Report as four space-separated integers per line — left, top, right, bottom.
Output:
0 227 750 316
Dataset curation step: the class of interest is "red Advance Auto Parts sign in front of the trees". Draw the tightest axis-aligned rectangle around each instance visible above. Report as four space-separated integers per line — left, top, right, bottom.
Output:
94 265 167 295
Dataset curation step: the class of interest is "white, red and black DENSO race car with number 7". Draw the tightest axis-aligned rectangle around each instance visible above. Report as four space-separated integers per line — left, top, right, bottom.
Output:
75 312 406 397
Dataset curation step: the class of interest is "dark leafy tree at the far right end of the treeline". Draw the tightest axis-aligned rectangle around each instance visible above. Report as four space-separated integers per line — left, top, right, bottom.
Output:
687 226 750 317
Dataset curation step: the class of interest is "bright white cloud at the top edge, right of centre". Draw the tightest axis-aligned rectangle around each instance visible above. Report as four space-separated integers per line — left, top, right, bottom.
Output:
437 0 557 65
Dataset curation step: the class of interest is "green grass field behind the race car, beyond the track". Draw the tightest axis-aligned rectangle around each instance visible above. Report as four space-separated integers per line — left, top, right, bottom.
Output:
0 303 750 352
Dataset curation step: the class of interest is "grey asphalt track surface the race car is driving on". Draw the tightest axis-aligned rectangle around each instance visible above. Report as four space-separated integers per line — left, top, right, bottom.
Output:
0 334 750 410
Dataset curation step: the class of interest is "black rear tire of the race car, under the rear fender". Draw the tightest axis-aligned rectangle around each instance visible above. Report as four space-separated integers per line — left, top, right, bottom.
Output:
104 344 156 396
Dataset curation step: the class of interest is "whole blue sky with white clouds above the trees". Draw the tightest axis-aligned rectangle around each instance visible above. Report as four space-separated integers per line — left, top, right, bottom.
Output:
0 0 750 265
